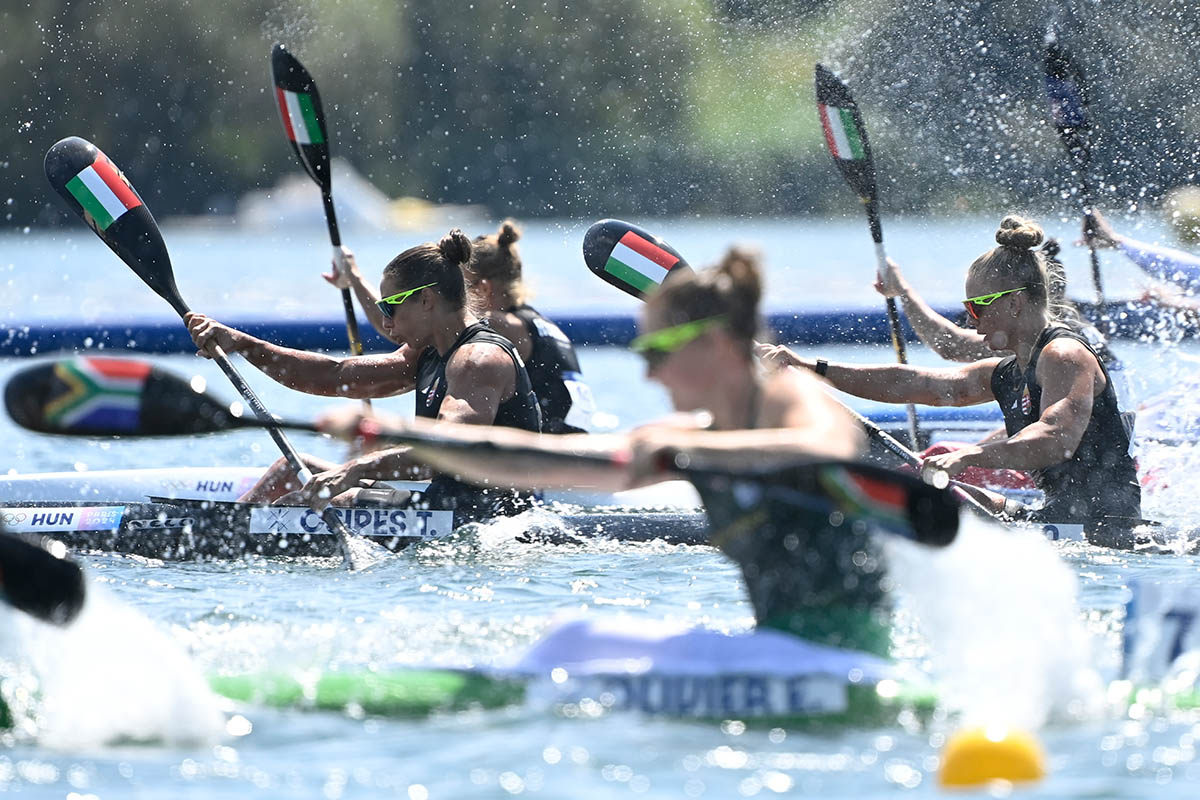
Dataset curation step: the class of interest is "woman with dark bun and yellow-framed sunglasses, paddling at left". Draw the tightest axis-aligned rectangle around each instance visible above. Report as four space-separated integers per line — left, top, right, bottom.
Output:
186 229 540 516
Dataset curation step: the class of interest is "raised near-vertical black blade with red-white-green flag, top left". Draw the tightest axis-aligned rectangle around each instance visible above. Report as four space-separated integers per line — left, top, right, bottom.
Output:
271 44 330 193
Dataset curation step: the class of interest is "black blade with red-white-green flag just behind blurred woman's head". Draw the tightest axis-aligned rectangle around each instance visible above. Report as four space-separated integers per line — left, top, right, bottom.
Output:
583 219 691 300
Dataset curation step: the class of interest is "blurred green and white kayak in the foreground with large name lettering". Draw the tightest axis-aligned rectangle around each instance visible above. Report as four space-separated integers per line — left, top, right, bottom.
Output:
0 619 936 727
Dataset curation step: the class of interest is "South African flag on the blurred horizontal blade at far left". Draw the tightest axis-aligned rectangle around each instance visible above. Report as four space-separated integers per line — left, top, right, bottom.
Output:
43 359 150 432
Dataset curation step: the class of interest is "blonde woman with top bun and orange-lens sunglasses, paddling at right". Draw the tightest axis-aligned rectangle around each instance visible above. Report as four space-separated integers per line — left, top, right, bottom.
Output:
763 216 1141 523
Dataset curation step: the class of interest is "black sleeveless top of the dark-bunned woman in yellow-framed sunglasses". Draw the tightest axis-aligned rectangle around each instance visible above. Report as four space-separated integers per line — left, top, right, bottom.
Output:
416 323 541 524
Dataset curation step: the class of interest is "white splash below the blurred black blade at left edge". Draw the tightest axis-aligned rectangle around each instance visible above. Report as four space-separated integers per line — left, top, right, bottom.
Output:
0 583 226 750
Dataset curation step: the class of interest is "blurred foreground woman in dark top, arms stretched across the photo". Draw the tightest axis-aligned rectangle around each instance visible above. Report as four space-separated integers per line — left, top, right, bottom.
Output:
330 252 890 654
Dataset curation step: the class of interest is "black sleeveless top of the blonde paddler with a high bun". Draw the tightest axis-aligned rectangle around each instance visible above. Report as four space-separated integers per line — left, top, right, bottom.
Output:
991 325 1141 523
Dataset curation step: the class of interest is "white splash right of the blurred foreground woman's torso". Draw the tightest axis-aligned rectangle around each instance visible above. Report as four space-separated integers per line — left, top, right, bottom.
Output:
886 513 1104 728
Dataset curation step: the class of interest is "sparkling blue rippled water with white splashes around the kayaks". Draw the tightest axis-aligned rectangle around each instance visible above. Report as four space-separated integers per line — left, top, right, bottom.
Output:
0 219 1200 799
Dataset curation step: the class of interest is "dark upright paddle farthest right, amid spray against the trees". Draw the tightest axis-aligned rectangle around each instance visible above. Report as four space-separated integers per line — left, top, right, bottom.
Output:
1045 36 1111 311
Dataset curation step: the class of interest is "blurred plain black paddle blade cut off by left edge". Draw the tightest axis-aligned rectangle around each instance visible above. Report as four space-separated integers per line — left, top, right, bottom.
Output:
0 530 86 625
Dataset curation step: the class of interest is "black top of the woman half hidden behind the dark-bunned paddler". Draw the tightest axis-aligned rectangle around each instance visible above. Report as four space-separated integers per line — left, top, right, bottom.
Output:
509 306 594 433
